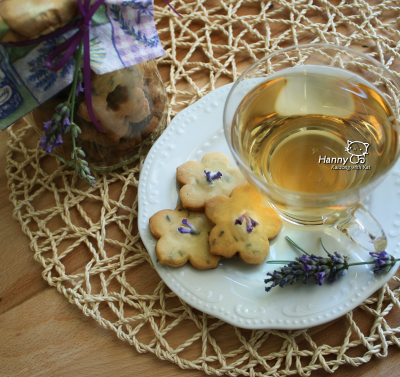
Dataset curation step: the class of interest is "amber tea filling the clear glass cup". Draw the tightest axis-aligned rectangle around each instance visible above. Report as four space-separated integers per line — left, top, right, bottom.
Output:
233 66 399 193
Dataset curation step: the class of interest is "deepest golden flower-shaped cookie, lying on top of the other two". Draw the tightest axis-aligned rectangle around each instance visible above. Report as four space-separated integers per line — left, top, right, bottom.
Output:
205 184 282 264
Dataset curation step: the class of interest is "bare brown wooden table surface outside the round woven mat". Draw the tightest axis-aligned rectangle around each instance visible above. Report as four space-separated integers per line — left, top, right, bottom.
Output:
0 1 400 377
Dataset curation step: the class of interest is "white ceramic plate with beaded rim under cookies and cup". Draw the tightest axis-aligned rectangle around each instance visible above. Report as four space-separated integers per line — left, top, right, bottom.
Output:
138 85 400 329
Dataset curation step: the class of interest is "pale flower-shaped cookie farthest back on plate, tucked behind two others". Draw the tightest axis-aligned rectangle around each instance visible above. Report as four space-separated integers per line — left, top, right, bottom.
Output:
176 152 246 211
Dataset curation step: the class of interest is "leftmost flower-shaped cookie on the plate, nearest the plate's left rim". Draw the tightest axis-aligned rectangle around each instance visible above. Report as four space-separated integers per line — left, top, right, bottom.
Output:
149 205 220 270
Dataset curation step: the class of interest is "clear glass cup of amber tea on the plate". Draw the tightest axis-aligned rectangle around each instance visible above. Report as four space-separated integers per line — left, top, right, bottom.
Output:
224 44 400 251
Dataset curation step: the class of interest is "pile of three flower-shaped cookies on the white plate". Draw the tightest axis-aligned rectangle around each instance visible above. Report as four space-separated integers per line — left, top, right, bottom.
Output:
150 152 282 269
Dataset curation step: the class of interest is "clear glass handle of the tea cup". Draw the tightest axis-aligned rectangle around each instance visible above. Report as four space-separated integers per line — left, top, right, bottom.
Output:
324 204 387 252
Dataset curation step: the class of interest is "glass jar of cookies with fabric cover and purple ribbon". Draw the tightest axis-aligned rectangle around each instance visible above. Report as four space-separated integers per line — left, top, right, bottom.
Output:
25 60 168 172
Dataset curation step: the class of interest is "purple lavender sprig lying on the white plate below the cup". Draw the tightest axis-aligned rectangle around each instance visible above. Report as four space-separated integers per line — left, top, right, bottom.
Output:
264 237 400 292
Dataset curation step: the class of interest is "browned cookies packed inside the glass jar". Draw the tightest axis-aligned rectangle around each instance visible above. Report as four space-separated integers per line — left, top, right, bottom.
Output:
77 63 166 160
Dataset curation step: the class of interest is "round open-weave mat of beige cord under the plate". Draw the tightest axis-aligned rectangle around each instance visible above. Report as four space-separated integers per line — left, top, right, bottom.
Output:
7 0 400 376
